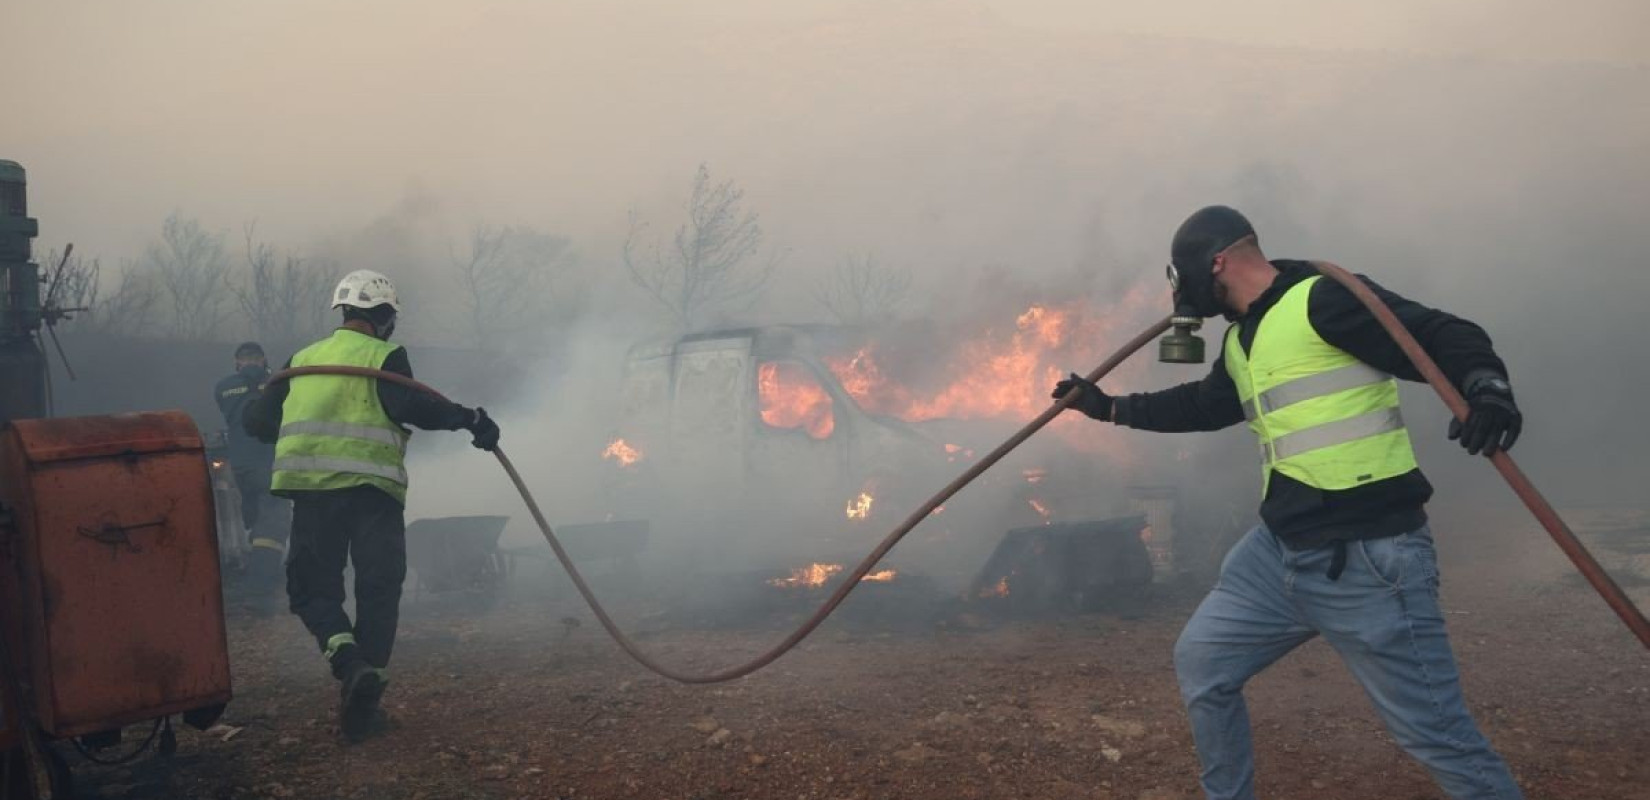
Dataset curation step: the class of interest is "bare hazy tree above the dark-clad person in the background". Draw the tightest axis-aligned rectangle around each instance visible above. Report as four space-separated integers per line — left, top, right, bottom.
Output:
143 213 229 341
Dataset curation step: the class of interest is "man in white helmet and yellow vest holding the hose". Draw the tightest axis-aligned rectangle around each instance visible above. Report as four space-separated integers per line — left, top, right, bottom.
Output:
244 269 498 741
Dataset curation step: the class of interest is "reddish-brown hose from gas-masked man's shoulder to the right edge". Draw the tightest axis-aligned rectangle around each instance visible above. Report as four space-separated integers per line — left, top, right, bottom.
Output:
1313 261 1650 648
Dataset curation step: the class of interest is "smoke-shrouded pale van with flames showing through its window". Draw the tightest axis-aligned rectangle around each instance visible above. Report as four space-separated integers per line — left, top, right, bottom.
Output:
602 327 947 560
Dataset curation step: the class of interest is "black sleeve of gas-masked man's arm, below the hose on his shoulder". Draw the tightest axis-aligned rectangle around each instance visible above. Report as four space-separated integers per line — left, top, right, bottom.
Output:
1307 275 1506 391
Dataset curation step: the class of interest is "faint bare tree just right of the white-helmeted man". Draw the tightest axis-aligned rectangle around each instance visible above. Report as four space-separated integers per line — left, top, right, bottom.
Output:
452 226 578 346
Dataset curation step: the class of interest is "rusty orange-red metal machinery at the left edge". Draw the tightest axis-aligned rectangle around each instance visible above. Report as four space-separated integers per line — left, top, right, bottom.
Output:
0 162 229 798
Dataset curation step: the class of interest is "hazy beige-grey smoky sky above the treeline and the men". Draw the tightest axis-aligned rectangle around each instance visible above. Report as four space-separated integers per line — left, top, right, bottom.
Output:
0 0 1650 504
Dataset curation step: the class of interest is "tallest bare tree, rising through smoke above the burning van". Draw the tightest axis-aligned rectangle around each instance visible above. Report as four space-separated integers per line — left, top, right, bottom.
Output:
624 163 779 328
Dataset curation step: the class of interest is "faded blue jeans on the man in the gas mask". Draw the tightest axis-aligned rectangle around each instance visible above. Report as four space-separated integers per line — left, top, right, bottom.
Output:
1175 526 1523 800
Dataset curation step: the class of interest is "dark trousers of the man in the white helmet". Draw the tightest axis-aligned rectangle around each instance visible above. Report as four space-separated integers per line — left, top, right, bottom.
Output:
287 487 408 668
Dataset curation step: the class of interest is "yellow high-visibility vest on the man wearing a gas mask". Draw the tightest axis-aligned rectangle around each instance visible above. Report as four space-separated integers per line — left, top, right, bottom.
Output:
1224 275 1416 495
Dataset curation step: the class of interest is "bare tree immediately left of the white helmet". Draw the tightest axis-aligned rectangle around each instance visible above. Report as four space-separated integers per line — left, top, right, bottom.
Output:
231 223 337 343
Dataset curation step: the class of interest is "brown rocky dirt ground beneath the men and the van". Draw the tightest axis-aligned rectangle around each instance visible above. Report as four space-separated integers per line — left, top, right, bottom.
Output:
51 508 1650 800
